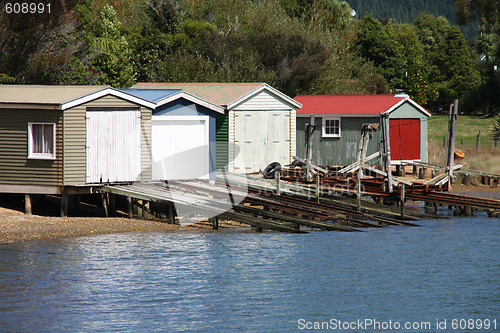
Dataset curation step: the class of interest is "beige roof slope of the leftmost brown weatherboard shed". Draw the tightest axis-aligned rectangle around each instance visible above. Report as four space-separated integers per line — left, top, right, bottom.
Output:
0 85 109 105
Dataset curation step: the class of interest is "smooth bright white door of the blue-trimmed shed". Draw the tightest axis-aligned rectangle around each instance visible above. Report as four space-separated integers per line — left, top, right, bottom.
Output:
152 116 209 180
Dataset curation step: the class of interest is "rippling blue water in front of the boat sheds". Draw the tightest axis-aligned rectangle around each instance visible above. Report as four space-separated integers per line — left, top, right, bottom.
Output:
0 218 500 332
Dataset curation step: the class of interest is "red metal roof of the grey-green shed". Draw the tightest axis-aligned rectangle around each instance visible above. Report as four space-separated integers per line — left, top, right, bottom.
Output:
294 95 410 115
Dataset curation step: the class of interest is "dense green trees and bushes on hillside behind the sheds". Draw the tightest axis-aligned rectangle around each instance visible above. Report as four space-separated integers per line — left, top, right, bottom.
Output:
0 0 500 114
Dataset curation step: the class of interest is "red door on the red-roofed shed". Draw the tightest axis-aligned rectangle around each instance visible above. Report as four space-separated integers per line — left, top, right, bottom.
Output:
389 119 420 161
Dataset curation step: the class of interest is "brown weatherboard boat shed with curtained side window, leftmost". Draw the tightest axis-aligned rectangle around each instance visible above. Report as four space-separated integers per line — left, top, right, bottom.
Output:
0 85 155 194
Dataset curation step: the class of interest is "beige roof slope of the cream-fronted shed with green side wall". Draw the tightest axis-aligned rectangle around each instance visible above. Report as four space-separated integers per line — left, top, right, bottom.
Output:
132 83 264 106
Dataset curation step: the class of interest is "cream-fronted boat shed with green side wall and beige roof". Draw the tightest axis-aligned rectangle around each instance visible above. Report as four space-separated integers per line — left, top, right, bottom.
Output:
134 83 301 173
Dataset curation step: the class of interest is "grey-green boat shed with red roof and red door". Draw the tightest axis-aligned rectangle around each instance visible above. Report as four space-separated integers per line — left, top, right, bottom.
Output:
295 95 431 166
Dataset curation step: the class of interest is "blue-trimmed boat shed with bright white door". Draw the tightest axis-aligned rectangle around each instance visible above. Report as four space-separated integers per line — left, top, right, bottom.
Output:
121 88 224 180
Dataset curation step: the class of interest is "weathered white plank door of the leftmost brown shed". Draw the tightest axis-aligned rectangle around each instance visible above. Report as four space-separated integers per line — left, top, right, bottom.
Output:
86 110 141 183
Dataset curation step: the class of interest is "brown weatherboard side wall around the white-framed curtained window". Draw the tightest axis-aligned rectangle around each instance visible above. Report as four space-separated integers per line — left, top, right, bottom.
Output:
0 109 62 186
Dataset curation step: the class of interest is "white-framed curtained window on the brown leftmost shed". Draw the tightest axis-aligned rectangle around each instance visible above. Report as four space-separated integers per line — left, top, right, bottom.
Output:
28 123 56 160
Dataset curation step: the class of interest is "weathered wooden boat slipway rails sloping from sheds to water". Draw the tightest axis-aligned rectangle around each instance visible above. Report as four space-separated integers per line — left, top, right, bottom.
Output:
96 167 500 233
